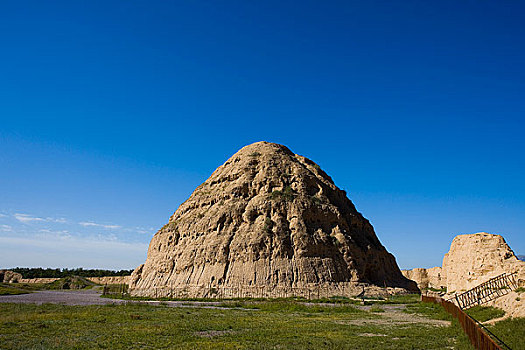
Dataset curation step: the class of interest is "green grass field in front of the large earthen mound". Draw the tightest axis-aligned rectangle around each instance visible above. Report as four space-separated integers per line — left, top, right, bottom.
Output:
0 301 471 350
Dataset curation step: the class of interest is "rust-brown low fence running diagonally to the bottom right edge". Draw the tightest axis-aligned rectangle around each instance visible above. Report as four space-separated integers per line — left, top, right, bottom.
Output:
421 295 510 350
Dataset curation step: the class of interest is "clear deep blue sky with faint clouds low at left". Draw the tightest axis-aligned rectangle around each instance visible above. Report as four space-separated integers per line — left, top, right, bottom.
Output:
0 1 525 268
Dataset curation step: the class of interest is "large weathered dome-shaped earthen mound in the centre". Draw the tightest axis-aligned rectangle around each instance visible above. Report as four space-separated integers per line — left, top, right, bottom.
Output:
130 142 416 296
